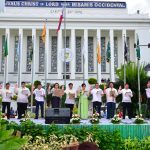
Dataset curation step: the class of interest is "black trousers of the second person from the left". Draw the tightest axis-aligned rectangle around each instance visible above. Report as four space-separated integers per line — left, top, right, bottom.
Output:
17 102 28 119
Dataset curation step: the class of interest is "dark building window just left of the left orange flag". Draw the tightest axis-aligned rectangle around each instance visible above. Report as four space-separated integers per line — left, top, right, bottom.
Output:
39 36 45 72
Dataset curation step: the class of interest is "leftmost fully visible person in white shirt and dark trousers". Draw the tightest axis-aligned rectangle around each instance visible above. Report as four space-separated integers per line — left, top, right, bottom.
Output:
1 83 13 119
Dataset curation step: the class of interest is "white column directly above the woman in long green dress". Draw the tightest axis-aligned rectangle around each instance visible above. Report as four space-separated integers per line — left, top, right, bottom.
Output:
84 29 88 80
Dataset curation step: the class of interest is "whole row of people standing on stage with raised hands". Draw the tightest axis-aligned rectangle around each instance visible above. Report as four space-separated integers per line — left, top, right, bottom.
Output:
0 81 150 119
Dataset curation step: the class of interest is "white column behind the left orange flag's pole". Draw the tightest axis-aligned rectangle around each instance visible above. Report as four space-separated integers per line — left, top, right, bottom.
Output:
45 29 49 82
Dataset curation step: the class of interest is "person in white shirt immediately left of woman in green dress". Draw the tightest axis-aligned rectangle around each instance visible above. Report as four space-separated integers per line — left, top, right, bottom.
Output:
64 83 76 118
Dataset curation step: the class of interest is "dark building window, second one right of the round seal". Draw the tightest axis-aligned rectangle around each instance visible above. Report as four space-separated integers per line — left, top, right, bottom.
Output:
88 37 94 72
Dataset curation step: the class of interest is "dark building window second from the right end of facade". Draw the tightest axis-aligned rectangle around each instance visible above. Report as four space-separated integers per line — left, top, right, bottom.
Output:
114 37 118 70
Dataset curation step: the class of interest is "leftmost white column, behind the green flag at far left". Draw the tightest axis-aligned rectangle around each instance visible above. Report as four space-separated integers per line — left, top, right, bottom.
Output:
4 28 11 83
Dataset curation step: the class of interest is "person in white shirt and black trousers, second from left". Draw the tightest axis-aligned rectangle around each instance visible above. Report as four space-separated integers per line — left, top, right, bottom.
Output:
15 82 31 119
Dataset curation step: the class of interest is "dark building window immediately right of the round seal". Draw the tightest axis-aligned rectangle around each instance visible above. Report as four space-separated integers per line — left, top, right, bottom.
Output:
76 37 82 72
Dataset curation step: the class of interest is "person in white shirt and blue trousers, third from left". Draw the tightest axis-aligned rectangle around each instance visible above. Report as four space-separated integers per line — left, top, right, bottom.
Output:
33 83 45 119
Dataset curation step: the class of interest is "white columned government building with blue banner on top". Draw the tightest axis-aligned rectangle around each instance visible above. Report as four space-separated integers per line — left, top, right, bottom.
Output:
0 0 150 84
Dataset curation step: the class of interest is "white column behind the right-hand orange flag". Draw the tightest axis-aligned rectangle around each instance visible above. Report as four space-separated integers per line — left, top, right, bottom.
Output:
96 29 102 84
